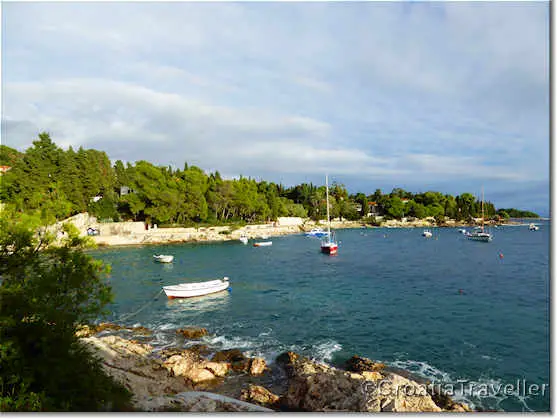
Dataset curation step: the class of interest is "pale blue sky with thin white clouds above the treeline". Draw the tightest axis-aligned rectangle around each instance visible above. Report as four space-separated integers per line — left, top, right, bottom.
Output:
1 2 550 216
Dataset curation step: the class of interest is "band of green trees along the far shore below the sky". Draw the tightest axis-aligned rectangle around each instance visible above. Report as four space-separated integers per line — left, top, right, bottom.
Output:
0 132 537 226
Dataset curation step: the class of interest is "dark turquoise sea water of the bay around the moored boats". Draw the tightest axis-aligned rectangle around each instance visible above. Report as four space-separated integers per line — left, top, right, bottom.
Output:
92 222 550 411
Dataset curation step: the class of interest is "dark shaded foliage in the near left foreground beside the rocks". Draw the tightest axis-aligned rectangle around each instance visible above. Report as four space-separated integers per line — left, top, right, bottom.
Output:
0 210 130 411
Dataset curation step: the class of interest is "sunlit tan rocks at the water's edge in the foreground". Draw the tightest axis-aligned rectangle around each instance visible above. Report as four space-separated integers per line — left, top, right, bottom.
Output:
78 323 471 412
